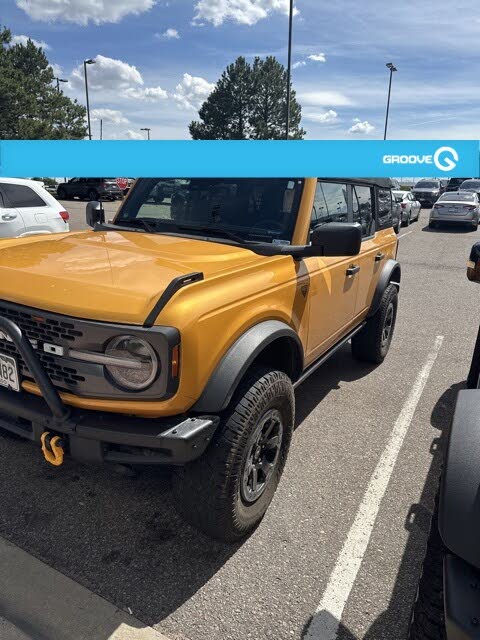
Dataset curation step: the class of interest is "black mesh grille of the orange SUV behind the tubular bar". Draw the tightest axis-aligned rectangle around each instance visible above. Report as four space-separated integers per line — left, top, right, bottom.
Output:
0 302 85 390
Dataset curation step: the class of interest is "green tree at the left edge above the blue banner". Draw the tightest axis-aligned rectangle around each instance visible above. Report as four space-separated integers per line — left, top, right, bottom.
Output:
0 28 87 140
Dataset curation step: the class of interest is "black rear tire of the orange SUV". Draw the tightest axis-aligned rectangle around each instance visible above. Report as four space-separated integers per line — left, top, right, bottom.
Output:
352 284 398 364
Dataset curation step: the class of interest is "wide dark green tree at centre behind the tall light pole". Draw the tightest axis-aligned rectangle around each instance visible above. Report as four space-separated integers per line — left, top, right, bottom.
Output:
189 56 305 140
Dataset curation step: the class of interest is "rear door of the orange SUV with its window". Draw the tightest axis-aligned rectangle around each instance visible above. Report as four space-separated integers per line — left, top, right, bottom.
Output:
352 185 397 319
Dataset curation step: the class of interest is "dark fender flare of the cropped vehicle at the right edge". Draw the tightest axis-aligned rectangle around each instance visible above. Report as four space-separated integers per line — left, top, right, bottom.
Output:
438 389 480 568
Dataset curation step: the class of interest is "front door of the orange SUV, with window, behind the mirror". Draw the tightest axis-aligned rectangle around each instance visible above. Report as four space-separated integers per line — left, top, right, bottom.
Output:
304 180 358 362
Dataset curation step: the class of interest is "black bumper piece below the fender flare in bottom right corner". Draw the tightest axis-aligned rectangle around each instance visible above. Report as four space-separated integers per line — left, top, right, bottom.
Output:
443 555 480 640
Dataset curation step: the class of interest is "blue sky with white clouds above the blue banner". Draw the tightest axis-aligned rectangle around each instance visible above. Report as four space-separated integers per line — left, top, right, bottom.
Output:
0 0 480 139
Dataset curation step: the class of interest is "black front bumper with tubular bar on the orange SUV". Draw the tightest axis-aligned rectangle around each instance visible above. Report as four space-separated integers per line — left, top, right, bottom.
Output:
0 317 218 465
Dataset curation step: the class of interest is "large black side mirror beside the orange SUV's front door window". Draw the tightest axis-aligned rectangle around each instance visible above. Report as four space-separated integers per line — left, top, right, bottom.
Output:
306 222 362 257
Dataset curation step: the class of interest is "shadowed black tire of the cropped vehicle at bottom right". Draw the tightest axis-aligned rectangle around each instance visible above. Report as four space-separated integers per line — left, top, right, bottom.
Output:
408 498 446 640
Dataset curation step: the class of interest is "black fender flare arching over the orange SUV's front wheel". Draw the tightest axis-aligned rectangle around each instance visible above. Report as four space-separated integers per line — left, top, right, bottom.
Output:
192 320 303 413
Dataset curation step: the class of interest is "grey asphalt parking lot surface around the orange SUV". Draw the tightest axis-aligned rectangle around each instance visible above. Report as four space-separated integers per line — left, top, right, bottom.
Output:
0 206 474 640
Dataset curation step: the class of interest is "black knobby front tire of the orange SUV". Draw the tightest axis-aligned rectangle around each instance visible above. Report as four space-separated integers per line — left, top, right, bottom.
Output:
173 368 295 542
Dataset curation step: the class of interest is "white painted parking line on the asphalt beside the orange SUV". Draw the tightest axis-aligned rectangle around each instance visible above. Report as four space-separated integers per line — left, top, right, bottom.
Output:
305 336 443 640
